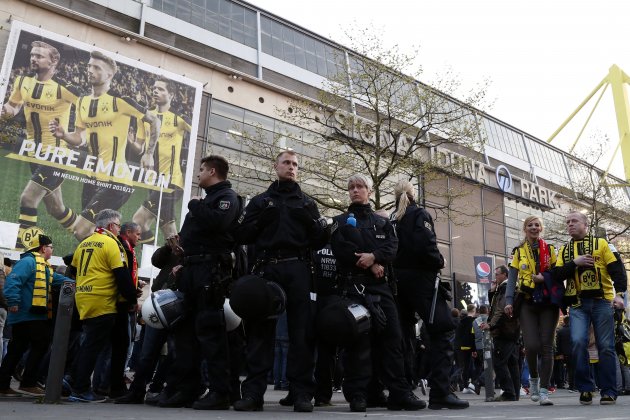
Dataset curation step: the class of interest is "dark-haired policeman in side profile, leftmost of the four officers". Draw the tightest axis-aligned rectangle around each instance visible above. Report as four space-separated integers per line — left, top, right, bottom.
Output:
158 155 241 410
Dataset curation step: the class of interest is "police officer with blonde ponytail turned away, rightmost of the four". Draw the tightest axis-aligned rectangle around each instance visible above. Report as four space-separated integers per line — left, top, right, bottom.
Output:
392 180 469 410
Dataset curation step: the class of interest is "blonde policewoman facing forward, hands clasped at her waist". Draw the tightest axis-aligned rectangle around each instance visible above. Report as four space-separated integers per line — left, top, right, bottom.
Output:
331 174 426 412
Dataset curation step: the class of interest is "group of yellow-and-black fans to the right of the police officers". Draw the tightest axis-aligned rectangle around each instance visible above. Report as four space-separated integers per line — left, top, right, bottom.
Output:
455 212 630 406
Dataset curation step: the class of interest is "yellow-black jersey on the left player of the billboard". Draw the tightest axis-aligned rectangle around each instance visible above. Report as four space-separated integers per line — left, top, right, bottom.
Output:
9 76 78 156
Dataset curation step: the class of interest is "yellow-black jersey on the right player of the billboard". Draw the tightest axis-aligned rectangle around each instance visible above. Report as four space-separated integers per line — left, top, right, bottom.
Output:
145 110 191 188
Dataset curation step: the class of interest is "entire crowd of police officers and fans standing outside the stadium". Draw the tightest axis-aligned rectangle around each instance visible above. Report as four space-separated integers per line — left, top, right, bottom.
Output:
0 150 630 412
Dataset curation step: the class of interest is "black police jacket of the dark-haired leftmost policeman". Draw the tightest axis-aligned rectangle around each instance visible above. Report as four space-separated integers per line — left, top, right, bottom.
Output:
179 181 241 256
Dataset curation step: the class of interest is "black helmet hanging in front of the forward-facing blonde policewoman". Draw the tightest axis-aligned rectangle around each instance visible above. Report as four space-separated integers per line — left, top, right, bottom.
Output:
316 297 371 346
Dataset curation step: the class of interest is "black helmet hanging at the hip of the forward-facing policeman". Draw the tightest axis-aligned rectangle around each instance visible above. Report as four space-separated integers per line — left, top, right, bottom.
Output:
230 275 286 320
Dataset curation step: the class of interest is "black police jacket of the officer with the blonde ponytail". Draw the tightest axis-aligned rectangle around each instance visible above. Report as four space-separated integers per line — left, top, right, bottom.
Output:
394 202 444 272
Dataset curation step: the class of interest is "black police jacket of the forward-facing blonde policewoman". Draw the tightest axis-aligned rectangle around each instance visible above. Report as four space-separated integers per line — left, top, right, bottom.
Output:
330 204 398 284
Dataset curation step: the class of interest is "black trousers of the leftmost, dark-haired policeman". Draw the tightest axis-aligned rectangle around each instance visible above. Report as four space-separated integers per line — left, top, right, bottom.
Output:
166 261 231 401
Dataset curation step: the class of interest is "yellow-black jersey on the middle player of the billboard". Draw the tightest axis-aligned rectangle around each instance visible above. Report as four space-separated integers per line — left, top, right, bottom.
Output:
76 93 145 182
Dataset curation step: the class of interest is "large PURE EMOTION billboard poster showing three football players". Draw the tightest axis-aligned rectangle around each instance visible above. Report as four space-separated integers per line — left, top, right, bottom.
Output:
0 21 202 262
